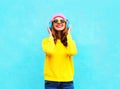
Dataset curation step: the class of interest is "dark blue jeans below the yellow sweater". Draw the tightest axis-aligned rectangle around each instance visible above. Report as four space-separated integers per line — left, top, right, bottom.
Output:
45 80 74 89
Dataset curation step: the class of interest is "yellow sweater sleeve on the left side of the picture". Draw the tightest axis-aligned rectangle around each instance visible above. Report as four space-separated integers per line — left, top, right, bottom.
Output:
42 36 55 54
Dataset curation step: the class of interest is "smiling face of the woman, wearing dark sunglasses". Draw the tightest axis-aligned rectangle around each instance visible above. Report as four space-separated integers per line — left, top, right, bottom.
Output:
53 17 66 31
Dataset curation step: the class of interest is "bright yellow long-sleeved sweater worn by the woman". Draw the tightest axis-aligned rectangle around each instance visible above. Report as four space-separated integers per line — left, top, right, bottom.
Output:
42 34 77 82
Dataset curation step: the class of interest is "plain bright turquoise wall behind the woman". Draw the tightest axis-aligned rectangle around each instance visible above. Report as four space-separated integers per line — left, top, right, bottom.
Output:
0 0 120 89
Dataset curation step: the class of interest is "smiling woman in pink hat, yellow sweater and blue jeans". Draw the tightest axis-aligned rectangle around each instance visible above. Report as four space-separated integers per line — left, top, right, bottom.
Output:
42 14 77 89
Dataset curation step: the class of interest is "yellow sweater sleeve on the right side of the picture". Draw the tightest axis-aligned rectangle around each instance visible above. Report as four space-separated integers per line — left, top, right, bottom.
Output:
67 34 77 56
